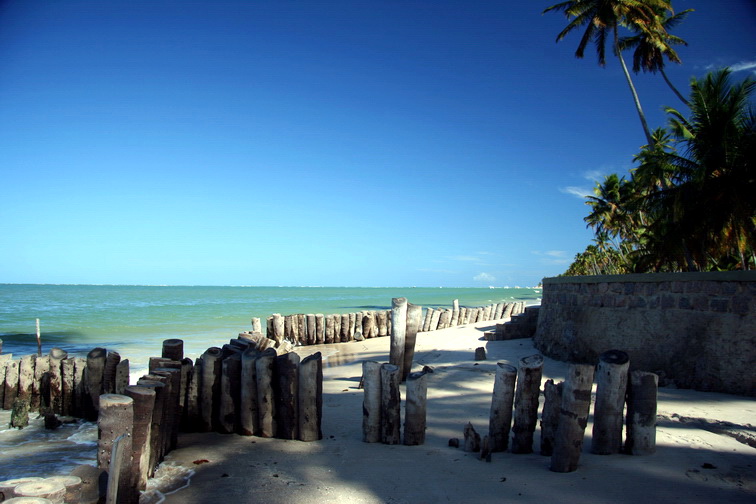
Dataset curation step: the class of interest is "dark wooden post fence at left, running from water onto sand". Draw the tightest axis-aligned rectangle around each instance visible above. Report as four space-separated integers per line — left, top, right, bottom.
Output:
0 333 323 503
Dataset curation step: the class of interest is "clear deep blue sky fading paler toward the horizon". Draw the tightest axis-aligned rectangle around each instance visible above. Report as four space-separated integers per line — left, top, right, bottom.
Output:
0 0 756 286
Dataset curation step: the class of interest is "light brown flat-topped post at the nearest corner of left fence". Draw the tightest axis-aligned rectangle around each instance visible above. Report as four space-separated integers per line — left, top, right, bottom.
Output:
97 394 134 503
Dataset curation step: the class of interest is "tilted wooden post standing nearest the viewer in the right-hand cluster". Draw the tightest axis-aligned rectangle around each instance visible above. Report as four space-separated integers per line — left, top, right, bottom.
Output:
550 364 594 472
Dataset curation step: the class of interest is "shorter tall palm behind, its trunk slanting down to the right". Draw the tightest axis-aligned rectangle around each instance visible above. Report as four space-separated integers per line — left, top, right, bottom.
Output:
619 9 693 105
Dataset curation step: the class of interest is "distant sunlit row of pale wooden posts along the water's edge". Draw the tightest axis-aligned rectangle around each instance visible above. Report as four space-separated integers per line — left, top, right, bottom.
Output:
260 299 525 345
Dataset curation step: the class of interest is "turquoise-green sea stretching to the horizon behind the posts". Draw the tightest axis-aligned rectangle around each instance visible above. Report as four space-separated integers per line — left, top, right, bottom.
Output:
0 284 540 369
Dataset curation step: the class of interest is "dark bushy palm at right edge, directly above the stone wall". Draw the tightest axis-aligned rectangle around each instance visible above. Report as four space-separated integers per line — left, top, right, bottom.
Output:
663 69 756 269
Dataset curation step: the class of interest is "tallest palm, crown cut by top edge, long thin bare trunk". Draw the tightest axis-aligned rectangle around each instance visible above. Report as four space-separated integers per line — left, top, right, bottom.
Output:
543 0 672 144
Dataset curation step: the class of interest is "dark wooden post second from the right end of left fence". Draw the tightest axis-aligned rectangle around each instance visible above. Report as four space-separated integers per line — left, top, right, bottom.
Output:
273 352 300 439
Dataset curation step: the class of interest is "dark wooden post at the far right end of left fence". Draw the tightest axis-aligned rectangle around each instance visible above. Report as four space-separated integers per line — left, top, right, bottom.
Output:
298 352 323 441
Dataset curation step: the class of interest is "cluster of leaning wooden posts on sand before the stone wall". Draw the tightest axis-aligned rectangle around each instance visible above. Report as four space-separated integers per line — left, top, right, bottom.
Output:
478 350 658 472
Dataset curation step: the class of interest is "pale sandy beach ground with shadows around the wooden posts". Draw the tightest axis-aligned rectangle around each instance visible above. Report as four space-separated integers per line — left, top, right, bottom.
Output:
154 322 756 504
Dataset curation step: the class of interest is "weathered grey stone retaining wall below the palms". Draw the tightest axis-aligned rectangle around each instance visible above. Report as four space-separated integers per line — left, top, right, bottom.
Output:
534 271 756 396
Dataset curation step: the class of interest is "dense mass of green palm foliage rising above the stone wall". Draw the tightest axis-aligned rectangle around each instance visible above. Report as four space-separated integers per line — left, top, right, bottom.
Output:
566 69 756 275
